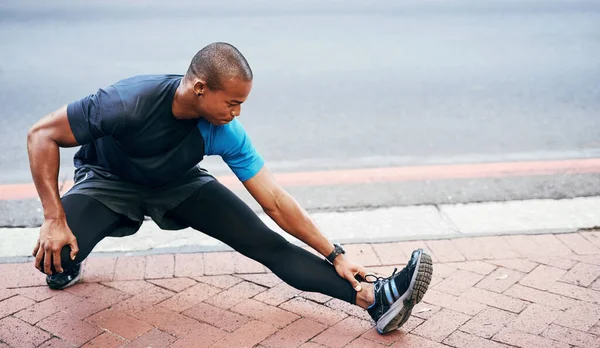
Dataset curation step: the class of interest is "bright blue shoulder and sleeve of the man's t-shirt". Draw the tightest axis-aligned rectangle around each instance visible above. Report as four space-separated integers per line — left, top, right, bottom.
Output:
198 118 265 182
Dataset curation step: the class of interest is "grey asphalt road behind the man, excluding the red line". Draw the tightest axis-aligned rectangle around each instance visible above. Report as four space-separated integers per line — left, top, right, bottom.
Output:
0 0 600 225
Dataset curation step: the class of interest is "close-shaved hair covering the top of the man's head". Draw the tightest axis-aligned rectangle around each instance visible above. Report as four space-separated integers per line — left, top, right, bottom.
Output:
186 42 252 90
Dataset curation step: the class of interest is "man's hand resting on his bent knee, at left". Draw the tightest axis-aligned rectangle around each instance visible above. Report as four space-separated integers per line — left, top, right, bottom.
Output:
33 218 79 275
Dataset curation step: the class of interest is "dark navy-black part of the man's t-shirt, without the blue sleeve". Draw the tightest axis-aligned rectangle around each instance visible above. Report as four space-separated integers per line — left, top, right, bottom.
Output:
67 75 205 186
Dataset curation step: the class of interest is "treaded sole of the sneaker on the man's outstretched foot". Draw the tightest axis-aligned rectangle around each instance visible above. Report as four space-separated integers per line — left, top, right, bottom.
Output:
376 252 433 334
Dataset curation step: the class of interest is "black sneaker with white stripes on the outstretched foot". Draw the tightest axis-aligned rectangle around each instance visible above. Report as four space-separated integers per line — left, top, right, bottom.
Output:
365 249 433 334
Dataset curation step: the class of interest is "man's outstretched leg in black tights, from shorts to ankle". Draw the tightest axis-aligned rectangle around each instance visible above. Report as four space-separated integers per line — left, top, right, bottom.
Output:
168 181 356 304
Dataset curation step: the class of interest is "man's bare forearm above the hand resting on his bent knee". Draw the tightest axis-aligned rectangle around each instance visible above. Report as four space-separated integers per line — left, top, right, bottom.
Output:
27 127 65 219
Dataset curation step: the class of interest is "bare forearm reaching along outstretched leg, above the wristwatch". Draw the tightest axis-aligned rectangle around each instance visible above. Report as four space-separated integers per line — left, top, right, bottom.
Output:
266 192 333 256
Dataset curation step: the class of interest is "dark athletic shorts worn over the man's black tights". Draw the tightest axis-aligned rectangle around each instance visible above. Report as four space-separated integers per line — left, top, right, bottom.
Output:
64 166 216 237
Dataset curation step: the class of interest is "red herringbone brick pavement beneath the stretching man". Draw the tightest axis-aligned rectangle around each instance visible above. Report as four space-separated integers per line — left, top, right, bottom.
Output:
0 231 600 348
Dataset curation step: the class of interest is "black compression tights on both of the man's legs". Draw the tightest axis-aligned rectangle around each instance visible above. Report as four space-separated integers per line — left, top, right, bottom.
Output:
51 181 356 304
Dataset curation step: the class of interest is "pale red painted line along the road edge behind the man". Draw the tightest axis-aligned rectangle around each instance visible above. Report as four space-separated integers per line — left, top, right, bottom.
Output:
0 158 600 200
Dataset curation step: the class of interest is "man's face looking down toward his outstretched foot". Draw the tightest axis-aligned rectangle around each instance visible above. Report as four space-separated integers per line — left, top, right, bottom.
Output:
198 78 252 126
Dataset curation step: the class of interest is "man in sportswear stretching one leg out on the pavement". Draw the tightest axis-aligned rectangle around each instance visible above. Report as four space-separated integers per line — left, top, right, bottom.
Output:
28 43 432 333
